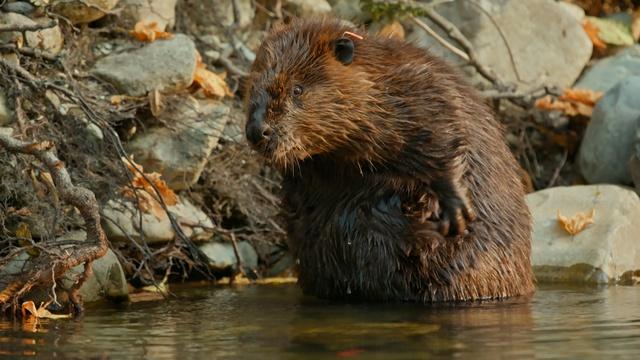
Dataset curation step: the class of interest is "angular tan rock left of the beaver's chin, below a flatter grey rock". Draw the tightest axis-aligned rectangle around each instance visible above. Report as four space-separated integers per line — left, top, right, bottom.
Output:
128 96 229 190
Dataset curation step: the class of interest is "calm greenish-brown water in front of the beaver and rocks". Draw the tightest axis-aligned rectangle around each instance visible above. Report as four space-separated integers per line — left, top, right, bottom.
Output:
0 285 640 360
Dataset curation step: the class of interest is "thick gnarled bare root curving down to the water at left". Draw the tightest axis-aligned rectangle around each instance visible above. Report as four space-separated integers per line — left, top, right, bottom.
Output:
0 133 109 312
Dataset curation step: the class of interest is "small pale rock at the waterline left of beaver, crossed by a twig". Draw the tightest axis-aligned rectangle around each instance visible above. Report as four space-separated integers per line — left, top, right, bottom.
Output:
200 241 258 271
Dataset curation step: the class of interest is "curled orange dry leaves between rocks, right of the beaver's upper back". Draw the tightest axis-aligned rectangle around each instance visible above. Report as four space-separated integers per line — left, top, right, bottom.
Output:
535 89 603 117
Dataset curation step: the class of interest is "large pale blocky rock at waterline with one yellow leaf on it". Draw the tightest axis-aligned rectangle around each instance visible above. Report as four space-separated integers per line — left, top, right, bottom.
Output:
527 185 640 283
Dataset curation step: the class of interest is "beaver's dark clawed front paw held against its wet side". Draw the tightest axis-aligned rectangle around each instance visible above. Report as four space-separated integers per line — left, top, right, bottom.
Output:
438 191 476 236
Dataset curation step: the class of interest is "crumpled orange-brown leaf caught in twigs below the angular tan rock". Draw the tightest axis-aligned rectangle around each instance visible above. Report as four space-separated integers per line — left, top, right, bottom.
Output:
121 157 178 219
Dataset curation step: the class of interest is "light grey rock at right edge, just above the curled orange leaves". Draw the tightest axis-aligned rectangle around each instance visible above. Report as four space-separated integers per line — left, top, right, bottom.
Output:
575 45 640 92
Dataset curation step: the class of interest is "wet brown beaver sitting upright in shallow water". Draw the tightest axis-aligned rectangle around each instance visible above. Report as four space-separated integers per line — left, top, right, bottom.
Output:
245 19 533 303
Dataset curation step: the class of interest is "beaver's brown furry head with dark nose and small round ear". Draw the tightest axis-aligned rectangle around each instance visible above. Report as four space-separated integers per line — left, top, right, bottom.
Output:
246 20 384 170
